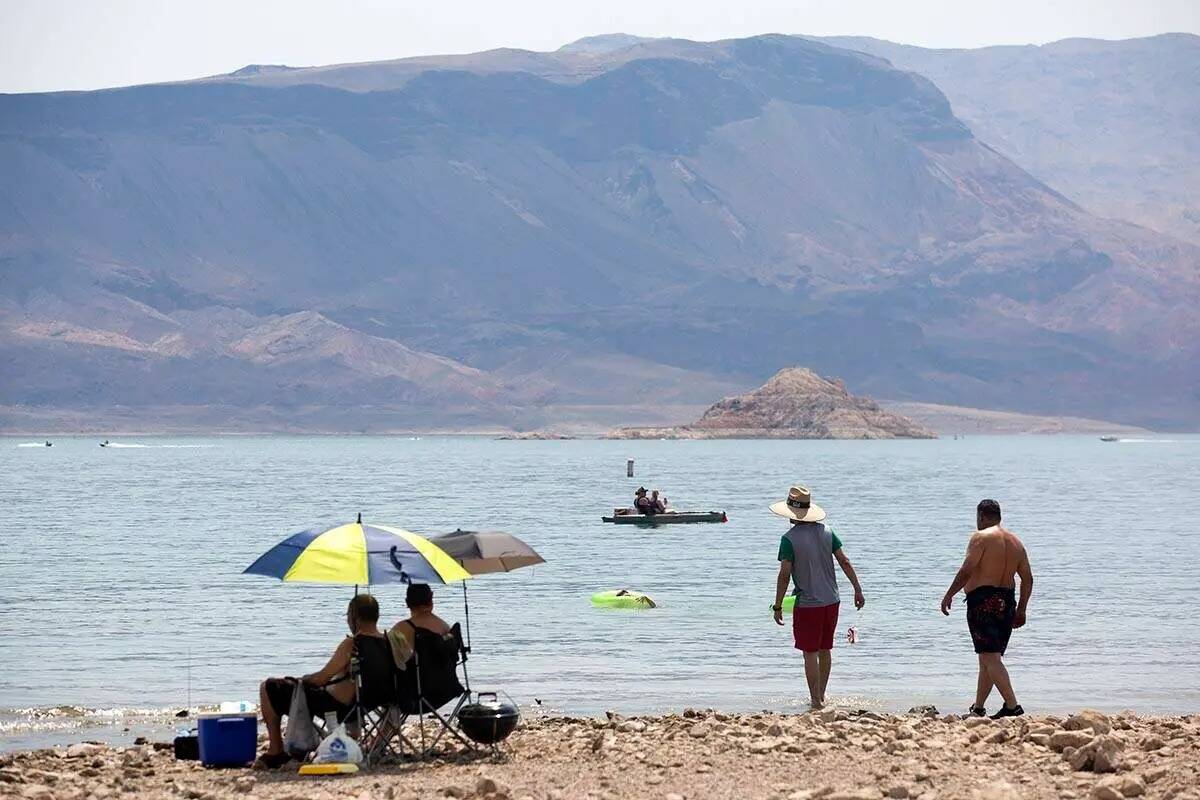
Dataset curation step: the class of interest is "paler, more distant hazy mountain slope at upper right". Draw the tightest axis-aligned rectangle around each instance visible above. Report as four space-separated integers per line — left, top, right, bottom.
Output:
823 34 1200 243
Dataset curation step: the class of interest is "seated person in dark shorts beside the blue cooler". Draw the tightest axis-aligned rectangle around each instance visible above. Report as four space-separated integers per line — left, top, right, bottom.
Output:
258 595 390 769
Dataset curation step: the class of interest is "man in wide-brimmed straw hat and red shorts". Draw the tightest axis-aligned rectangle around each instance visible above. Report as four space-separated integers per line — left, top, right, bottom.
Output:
770 486 866 709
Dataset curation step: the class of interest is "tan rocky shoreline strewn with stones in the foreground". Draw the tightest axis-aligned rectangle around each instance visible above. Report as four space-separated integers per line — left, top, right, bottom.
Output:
0 708 1200 800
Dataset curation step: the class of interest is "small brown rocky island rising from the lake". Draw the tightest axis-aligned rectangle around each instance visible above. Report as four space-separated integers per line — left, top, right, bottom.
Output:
607 367 937 439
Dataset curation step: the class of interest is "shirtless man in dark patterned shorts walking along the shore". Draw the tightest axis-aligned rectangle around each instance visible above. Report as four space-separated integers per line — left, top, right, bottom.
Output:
942 500 1033 720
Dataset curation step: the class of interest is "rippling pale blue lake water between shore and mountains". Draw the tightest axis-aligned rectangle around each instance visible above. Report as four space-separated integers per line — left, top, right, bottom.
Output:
0 435 1200 748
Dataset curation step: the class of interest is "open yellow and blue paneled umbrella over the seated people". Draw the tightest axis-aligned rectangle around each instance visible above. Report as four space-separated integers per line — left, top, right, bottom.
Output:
244 515 470 585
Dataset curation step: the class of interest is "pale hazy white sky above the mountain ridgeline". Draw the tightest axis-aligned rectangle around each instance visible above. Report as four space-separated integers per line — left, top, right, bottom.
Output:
0 0 1200 91
